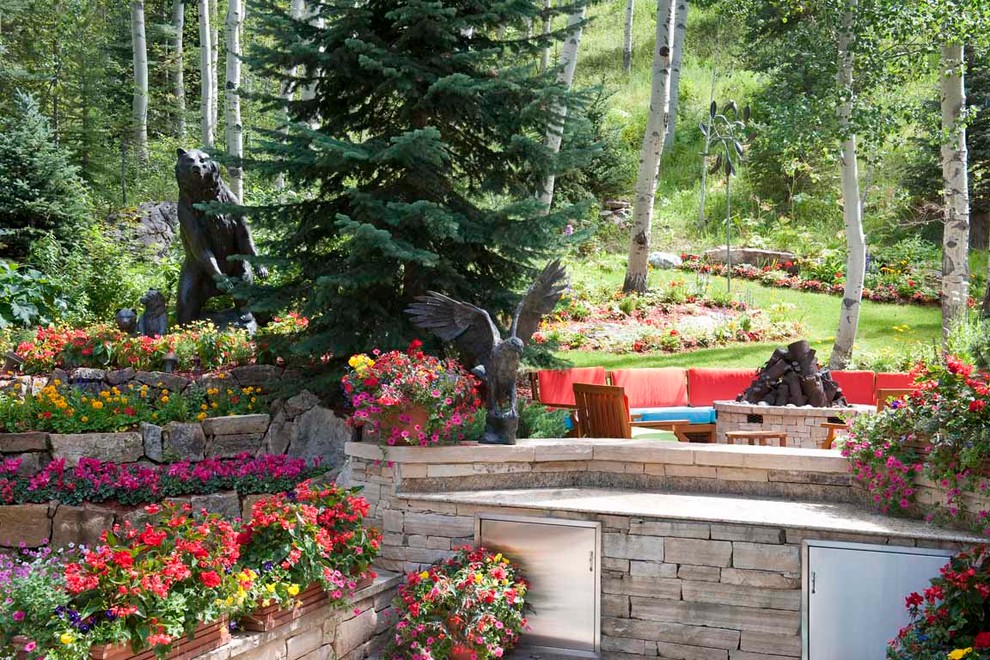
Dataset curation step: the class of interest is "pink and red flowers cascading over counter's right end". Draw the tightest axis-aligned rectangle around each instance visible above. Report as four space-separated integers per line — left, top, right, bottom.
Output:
842 355 990 534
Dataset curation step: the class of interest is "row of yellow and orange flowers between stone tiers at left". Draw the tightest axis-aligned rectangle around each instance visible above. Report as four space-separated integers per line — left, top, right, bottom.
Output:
0 374 267 433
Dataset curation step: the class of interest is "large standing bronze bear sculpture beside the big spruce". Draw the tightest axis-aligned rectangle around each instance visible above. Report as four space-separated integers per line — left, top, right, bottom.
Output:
175 149 268 325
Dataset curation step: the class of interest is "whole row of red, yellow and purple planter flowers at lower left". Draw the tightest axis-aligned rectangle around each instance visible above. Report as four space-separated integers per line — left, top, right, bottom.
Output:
0 483 379 660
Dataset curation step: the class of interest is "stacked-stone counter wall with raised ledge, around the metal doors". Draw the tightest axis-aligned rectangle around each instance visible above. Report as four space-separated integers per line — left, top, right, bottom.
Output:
344 440 979 660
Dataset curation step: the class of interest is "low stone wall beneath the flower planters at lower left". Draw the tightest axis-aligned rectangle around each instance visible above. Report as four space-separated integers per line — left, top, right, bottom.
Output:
205 575 400 660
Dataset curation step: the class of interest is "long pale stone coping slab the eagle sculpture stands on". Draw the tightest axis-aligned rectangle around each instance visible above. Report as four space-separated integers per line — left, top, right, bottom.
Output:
344 438 849 474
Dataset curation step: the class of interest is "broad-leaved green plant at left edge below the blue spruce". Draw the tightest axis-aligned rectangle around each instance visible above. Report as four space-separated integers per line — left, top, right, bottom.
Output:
0 259 67 330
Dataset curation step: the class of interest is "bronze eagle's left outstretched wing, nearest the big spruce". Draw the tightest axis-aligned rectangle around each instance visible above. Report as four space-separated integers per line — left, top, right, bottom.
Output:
406 291 501 365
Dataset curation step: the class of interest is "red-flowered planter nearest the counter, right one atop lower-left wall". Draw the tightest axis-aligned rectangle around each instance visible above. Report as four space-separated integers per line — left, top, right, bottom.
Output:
237 481 381 630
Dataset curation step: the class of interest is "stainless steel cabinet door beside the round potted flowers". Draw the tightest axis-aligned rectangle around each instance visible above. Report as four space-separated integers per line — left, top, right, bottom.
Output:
479 518 600 652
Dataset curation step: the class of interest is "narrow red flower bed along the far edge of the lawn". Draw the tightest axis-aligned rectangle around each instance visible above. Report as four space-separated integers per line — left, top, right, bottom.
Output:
679 253 939 305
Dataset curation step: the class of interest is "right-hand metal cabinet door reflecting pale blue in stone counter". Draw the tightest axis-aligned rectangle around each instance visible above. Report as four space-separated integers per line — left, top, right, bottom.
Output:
804 541 951 660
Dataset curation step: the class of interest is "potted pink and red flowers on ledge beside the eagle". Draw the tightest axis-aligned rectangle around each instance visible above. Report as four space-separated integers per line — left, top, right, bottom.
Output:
342 341 481 447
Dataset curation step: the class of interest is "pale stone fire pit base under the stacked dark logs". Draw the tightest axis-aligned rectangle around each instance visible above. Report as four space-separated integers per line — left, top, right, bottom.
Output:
715 401 876 449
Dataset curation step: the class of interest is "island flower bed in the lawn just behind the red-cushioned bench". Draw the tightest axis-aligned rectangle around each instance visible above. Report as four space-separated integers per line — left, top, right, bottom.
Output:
533 280 801 353
